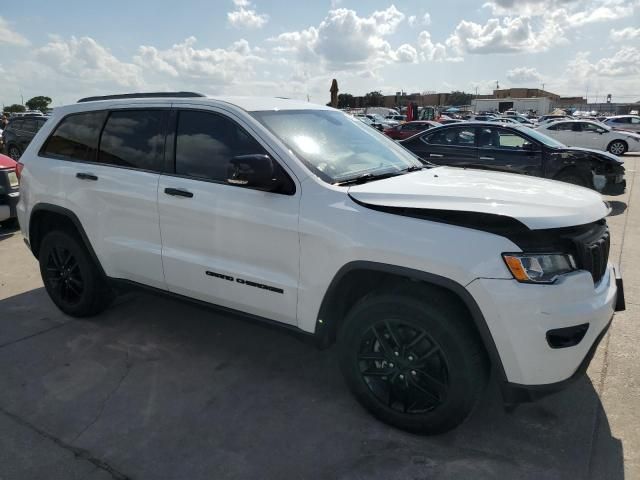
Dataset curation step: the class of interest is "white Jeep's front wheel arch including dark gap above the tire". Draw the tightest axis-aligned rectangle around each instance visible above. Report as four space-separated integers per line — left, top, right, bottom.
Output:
315 261 507 382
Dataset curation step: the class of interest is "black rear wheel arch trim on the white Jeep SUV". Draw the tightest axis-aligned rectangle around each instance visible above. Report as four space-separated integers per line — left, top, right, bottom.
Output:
29 203 106 277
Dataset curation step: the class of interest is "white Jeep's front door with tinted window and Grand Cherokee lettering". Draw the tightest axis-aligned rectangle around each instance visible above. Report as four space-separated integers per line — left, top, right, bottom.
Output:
158 109 300 324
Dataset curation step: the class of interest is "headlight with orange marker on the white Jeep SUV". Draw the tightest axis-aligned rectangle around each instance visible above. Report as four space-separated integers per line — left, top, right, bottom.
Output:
502 253 576 283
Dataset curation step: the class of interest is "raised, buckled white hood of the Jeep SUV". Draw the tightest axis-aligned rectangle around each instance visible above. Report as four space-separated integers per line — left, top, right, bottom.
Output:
349 167 609 230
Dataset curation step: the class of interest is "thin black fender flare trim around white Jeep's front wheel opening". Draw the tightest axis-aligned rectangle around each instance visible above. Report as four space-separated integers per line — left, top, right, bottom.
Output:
315 261 507 383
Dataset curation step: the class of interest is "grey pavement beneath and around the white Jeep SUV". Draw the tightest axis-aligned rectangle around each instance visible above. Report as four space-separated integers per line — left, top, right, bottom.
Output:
0 155 640 480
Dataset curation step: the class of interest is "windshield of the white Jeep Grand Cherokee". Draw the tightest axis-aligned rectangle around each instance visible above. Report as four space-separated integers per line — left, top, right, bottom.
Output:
252 110 424 183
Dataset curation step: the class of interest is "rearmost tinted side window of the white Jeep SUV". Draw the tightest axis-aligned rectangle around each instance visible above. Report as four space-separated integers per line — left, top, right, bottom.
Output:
44 112 107 161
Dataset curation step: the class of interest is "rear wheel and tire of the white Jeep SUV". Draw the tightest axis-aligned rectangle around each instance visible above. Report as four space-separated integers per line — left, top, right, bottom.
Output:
38 230 113 317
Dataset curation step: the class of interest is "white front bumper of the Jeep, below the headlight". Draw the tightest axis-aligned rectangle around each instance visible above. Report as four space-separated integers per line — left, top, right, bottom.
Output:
467 265 618 389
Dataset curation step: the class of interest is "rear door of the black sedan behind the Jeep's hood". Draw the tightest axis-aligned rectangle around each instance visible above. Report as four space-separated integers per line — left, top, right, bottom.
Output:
410 126 478 167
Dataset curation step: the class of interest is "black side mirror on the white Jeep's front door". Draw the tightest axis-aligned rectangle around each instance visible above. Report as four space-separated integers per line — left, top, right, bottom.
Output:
227 154 282 192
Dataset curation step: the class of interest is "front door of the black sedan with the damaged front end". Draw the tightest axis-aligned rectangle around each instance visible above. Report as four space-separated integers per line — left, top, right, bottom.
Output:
475 126 542 177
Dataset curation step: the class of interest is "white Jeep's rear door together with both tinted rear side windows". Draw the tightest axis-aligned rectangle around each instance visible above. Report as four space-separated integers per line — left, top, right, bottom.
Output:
43 106 169 289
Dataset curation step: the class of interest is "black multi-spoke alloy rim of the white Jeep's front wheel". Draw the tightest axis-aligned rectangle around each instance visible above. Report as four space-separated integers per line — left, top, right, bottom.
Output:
358 319 449 414
